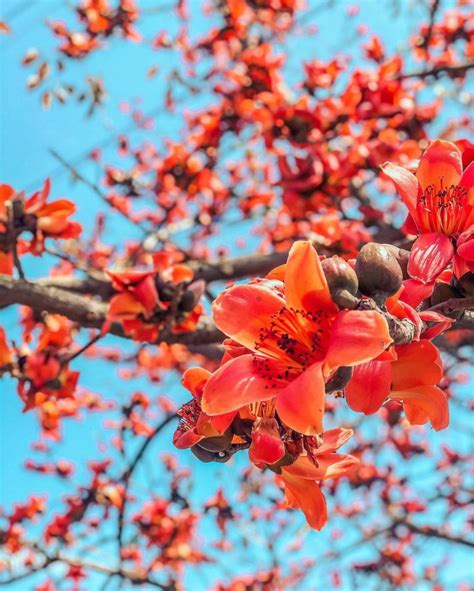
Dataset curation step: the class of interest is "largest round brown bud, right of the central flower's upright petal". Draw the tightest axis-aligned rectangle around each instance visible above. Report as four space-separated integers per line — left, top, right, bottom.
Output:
355 242 403 303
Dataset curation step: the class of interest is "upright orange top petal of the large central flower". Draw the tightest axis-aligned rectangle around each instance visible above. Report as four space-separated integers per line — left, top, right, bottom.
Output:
285 240 337 311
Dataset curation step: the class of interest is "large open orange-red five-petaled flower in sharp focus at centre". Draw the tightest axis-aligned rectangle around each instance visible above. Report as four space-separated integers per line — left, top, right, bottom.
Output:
201 241 392 435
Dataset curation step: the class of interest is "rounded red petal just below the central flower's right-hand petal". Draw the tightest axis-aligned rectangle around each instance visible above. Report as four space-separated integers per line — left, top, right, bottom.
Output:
346 361 392 415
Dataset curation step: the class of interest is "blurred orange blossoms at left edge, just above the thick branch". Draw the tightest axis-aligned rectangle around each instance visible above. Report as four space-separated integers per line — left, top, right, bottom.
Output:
0 180 82 275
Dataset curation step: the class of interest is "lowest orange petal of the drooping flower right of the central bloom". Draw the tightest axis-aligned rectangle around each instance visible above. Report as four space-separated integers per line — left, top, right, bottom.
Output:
390 386 449 431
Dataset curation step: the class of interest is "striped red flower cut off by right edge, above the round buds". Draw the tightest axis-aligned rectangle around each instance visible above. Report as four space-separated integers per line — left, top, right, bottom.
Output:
383 140 474 305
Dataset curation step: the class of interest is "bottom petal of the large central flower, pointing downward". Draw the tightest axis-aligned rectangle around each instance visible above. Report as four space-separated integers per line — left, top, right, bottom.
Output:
276 362 326 435
